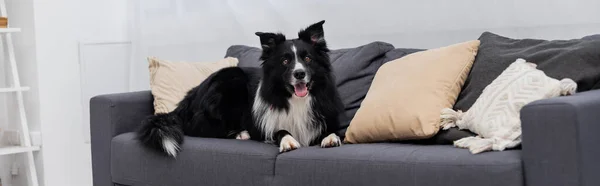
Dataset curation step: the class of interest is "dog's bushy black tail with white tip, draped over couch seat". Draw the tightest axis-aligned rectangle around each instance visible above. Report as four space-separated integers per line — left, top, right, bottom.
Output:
137 113 183 157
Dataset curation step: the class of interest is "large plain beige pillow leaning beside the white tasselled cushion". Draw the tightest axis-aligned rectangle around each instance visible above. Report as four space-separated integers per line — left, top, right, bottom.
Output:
345 40 479 143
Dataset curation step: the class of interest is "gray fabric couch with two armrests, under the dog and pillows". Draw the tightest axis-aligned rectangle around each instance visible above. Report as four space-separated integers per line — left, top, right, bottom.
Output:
90 32 600 186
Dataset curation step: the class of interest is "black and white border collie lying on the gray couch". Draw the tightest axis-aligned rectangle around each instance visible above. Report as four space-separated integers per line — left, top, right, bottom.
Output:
138 21 343 157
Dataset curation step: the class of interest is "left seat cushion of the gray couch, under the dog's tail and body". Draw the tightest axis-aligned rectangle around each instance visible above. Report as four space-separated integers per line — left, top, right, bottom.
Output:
111 133 279 186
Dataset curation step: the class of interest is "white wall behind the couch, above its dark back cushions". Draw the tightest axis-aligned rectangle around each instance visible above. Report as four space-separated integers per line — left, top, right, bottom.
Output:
131 0 600 90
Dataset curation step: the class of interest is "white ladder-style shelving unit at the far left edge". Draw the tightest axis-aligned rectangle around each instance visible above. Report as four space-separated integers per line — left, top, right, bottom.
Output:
0 0 40 186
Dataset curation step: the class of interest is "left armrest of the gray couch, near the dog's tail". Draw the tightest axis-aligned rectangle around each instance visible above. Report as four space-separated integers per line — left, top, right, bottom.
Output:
90 91 154 186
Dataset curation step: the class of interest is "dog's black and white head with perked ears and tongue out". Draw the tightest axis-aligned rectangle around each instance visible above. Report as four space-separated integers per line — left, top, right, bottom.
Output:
256 21 331 97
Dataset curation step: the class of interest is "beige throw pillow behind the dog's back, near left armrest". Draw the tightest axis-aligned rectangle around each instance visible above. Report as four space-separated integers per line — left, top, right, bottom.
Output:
148 57 238 114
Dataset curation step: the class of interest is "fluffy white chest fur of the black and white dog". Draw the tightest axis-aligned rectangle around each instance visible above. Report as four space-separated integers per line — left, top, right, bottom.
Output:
252 83 320 146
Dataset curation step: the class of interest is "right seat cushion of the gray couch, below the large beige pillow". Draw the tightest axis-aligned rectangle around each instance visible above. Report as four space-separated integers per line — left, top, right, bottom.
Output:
273 143 523 186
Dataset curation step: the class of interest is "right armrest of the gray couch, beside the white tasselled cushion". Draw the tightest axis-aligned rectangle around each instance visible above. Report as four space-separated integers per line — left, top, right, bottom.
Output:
521 90 600 186
